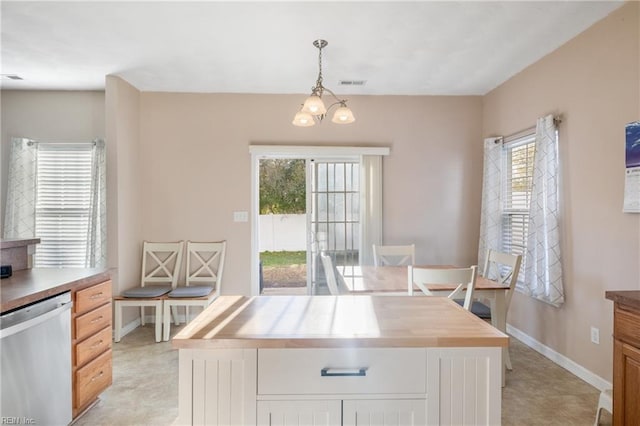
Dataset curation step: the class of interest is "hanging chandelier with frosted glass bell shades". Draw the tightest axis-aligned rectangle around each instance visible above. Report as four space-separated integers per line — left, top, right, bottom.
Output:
292 40 356 127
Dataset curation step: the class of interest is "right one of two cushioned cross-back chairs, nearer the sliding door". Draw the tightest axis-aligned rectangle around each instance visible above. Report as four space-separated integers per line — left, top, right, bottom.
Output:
163 241 227 341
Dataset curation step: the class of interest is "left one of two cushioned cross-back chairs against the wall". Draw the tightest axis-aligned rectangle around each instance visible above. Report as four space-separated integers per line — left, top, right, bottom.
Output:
114 241 184 342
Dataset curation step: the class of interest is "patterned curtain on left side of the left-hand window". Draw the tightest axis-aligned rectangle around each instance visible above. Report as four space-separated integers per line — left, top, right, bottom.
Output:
3 138 38 239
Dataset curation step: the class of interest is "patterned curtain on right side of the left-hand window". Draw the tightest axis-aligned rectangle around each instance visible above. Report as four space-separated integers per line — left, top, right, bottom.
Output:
86 140 107 268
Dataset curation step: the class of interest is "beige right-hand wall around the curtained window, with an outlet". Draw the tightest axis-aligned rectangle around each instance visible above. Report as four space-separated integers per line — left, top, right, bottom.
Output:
483 2 640 380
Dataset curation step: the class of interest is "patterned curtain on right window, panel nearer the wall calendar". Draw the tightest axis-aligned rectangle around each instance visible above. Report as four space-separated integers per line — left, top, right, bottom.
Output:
524 115 564 307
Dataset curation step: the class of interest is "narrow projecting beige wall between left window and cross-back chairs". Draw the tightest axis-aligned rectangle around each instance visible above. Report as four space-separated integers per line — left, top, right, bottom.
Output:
106 76 144 324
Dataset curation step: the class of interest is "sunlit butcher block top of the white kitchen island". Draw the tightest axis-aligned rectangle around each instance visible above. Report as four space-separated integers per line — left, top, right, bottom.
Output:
173 295 509 349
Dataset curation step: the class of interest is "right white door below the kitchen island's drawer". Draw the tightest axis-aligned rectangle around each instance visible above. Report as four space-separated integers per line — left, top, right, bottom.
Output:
342 399 427 426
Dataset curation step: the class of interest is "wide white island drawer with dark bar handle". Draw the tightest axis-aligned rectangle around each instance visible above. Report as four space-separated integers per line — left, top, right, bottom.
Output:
258 348 427 395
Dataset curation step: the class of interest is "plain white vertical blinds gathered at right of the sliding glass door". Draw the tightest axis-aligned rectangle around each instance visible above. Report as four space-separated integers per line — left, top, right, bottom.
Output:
360 155 382 265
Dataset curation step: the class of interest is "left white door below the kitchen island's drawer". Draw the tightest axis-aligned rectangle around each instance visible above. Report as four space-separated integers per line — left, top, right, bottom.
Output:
258 400 342 426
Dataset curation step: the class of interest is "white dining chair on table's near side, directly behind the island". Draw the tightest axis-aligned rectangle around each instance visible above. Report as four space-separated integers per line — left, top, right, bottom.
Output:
408 265 478 310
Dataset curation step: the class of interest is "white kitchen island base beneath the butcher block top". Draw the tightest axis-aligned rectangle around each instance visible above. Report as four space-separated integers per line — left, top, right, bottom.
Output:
176 347 502 426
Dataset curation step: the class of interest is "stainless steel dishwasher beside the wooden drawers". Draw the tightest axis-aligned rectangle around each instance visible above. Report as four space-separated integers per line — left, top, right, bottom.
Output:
0 292 72 426
